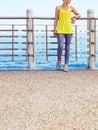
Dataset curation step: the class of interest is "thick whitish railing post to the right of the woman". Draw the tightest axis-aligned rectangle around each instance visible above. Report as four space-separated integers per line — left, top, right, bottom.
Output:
87 9 96 69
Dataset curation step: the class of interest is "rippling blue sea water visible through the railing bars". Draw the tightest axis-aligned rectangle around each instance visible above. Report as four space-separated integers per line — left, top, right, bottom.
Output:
0 32 98 70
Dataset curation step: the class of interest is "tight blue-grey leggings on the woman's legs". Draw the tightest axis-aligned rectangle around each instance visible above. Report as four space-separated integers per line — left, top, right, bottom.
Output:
57 34 72 64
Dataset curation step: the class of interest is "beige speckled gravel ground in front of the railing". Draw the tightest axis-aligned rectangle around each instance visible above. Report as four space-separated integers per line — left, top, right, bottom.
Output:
0 70 98 130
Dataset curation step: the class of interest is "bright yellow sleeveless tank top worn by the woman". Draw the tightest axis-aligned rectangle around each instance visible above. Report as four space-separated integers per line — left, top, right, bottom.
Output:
57 5 73 34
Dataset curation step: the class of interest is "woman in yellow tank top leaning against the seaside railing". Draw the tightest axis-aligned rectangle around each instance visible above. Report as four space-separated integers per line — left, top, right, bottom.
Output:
54 0 80 71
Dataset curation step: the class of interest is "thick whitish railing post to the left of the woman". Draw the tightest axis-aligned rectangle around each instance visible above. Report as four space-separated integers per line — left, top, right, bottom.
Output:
27 9 35 69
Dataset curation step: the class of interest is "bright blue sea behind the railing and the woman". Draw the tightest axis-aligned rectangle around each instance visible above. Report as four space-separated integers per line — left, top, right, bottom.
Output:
0 22 98 70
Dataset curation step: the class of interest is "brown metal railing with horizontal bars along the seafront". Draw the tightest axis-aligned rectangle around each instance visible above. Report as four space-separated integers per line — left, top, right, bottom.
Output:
0 17 98 70
